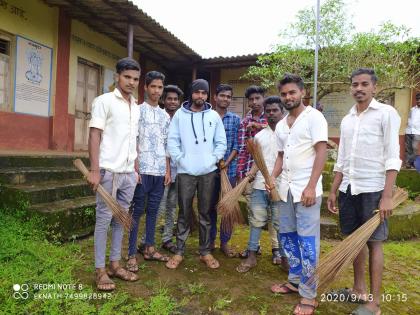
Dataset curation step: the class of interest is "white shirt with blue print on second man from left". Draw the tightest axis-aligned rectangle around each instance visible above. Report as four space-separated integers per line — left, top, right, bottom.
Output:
138 102 171 176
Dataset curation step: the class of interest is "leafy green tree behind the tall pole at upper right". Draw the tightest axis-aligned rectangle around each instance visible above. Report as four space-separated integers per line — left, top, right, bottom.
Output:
245 0 420 100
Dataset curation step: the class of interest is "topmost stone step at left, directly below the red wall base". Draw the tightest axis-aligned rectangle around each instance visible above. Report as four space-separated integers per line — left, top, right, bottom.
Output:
0 155 89 169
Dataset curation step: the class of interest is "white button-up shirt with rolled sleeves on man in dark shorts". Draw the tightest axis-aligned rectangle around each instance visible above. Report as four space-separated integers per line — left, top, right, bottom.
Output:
334 99 401 195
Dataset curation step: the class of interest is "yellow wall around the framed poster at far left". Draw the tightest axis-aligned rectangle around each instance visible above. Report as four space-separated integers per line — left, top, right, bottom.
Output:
0 0 58 115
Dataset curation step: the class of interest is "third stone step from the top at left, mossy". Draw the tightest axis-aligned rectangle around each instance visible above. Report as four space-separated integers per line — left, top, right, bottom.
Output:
7 179 93 205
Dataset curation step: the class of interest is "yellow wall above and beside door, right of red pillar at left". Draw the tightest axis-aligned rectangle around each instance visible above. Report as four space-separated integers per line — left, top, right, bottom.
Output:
68 20 139 114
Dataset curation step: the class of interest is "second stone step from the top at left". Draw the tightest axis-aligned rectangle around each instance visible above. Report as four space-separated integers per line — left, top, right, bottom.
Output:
0 166 82 185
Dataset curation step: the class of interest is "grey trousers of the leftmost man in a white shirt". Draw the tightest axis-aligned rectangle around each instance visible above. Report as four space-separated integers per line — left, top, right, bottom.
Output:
94 170 137 268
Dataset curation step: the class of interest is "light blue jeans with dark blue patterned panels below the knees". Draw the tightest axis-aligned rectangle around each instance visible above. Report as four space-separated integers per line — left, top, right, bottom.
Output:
279 190 322 299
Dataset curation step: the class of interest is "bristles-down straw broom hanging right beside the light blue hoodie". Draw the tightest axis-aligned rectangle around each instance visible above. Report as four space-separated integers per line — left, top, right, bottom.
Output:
219 160 245 233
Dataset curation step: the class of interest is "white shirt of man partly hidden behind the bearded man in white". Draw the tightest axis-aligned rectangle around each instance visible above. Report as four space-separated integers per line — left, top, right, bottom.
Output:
252 126 280 190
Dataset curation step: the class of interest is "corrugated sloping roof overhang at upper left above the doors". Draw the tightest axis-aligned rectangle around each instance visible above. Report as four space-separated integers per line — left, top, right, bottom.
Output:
44 0 202 69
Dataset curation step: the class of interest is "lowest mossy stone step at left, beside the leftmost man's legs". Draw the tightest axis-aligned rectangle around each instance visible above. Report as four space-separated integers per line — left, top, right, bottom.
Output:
29 196 95 241
